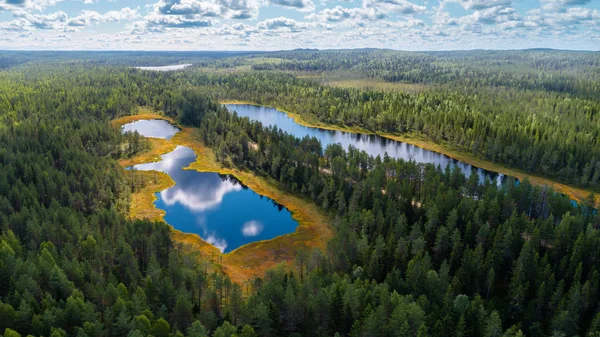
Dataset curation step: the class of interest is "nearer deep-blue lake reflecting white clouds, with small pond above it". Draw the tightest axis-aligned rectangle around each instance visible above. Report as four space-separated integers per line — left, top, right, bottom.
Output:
123 120 298 253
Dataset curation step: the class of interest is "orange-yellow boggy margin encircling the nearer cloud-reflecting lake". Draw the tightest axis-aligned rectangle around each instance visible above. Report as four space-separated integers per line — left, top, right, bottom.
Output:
111 108 333 284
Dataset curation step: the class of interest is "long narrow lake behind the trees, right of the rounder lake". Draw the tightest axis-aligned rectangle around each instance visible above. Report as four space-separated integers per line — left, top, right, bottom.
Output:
225 104 504 183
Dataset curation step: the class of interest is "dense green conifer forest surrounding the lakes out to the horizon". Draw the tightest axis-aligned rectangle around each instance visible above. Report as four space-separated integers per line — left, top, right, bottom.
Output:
0 51 600 337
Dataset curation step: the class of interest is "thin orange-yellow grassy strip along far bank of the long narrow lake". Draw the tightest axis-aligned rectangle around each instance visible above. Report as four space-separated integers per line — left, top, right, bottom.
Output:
220 100 593 202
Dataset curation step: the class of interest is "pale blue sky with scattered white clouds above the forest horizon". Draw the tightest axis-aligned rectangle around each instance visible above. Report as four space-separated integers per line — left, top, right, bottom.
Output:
0 0 600 51
